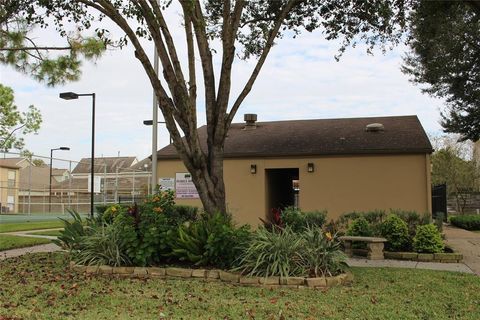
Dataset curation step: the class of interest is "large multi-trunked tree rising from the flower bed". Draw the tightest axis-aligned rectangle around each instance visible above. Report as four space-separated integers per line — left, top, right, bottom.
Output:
25 0 406 212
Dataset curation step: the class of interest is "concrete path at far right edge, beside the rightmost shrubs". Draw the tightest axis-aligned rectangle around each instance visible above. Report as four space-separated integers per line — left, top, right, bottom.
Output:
443 225 480 276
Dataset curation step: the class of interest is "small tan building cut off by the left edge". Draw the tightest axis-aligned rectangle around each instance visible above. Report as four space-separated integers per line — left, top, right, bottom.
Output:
0 159 20 213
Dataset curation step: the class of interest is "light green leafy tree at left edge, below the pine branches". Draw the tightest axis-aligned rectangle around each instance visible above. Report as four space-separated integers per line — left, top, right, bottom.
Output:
0 84 42 152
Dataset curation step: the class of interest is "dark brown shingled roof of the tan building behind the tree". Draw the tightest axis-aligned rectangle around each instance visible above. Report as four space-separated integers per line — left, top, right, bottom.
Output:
157 116 433 159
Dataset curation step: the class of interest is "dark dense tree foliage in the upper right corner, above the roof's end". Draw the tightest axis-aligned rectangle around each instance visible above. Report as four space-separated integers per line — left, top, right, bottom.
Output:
403 0 480 141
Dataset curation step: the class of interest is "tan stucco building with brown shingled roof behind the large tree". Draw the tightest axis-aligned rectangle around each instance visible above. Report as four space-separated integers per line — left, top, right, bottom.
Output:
158 116 432 225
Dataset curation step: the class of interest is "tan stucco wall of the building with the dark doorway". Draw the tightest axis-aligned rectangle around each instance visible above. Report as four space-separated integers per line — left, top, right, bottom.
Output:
158 154 431 226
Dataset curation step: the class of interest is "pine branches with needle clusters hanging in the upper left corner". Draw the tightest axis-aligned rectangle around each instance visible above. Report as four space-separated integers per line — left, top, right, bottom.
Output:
0 0 106 86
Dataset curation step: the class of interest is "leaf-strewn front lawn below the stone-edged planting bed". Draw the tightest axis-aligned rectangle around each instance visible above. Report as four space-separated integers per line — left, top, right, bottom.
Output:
0 253 480 320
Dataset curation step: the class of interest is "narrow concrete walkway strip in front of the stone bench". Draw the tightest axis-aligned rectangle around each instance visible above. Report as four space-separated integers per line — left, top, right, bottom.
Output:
347 258 474 273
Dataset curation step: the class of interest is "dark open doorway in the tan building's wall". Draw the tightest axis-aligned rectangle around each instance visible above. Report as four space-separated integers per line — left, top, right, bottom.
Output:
265 168 299 217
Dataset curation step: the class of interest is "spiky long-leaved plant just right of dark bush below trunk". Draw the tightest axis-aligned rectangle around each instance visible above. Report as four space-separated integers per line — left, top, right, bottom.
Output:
234 226 306 277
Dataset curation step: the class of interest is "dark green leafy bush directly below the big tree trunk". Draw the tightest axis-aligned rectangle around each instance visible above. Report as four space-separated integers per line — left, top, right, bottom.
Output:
169 213 250 268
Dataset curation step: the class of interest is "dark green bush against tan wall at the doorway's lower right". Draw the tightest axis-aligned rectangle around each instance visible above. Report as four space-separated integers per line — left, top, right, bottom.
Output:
280 207 327 231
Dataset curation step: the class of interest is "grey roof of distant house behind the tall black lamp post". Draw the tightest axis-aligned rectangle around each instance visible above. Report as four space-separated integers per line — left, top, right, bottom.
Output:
72 157 137 174
